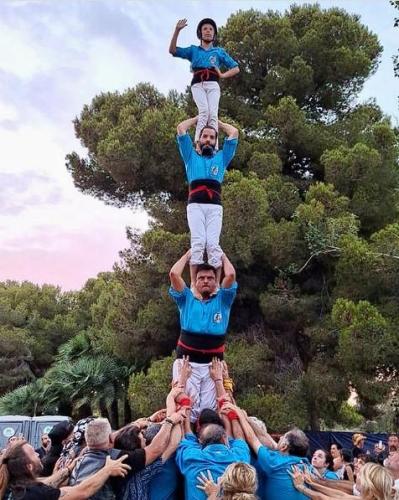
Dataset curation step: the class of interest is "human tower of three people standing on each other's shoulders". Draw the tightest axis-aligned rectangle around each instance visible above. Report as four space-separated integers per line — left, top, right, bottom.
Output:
169 18 239 421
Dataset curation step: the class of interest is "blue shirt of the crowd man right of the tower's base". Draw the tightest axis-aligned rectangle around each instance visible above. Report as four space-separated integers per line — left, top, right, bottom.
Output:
258 446 310 500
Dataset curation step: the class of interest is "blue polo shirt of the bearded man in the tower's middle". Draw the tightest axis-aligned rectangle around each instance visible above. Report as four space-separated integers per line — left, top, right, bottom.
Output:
177 133 238 183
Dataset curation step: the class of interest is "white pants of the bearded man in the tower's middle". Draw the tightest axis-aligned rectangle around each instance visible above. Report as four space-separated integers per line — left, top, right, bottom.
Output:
187 203 223 269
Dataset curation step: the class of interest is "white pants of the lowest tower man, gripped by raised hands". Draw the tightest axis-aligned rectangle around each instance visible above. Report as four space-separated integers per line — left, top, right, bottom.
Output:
173 359 217 422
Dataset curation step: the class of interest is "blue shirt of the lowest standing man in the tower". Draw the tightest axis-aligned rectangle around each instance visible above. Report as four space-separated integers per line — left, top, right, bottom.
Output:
169 282 237 335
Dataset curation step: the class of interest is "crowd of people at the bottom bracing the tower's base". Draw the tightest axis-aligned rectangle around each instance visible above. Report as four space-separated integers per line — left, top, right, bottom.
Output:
0 357 399 500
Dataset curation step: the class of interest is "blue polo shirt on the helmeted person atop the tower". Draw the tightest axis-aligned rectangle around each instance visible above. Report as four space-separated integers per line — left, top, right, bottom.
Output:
173 45 238 69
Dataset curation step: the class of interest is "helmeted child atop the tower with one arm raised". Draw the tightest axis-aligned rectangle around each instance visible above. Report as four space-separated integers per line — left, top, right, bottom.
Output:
169 18 240 144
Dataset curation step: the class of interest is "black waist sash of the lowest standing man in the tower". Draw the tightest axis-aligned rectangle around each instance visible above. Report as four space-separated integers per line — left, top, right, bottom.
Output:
176 330 225 363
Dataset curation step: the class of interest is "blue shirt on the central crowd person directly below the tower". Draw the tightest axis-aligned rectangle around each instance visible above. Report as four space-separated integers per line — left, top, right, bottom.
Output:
176 434 250 500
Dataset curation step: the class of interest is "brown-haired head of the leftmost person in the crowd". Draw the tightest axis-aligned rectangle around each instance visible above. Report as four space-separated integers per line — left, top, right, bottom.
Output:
0 440 43 492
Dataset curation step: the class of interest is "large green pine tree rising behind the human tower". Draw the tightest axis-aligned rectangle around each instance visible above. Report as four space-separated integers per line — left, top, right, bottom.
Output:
55 5 399 429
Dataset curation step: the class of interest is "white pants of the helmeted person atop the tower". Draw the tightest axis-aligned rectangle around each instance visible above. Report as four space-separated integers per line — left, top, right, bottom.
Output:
191 82 220 141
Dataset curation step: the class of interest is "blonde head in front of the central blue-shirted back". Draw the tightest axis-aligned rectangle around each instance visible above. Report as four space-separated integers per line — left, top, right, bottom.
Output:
219 462 258 500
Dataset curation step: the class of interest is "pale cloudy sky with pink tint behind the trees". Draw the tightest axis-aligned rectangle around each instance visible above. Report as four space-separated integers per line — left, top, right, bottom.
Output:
0 0 399 290
